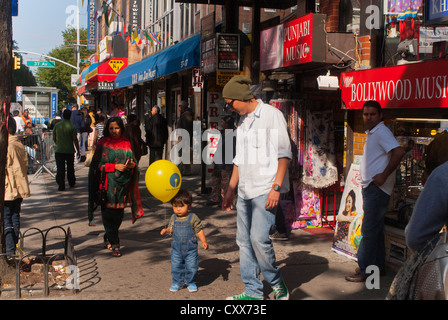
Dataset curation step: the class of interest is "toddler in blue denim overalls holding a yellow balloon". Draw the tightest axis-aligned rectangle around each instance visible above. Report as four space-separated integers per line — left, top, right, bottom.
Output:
160 189 208 292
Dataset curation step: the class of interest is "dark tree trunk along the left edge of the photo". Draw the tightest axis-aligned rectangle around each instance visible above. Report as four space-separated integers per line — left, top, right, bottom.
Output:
0 0 13 253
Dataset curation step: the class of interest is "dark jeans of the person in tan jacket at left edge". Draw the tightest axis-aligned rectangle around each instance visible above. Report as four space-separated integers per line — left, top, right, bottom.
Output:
4 198 23 254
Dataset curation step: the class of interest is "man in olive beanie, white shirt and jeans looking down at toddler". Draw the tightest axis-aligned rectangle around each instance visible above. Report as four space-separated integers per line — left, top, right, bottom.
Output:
222 76 292 300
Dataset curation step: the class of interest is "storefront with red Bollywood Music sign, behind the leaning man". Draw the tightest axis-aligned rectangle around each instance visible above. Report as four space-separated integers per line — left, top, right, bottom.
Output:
341 59 448 266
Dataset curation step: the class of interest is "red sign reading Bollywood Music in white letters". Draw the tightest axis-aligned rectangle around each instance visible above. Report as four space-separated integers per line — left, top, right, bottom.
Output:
341 59 448 109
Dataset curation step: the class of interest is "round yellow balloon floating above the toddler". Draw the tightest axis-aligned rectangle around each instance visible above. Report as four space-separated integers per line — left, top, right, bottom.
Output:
145 160 182 203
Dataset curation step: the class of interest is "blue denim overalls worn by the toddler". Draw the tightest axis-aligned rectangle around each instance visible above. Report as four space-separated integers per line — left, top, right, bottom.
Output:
171 213 199 286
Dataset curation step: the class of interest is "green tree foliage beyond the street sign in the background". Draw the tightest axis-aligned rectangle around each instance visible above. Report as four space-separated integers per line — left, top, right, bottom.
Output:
36 28 91 108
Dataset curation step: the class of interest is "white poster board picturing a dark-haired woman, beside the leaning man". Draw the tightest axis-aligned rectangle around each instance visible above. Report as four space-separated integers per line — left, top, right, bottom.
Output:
332 163 363 260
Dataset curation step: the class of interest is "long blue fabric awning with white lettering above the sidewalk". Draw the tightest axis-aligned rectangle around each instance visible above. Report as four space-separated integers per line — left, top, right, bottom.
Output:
115 34 201 89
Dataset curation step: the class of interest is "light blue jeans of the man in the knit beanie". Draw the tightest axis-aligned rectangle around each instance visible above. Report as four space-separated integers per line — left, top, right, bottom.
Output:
236 194 282 298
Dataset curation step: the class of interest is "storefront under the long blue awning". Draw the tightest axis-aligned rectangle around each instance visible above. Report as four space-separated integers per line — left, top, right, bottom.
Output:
114 35 201 161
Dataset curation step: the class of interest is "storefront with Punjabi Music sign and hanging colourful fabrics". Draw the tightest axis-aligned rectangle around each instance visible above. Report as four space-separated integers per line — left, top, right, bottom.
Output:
257 13 352 234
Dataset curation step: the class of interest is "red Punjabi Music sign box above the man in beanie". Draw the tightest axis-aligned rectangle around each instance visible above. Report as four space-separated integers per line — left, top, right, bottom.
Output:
260 13 326 71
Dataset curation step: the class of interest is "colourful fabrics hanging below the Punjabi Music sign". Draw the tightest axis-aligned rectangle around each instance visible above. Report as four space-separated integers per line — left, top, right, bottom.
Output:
269 99 338 229
